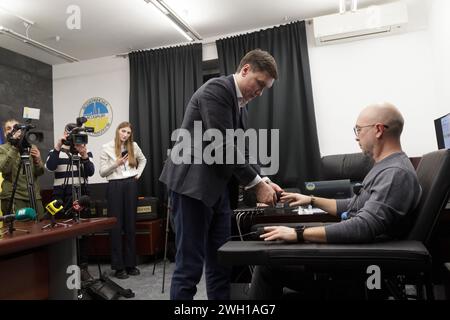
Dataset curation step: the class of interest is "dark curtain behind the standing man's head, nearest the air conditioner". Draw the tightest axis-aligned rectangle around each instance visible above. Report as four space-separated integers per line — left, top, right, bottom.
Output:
216 21 320 188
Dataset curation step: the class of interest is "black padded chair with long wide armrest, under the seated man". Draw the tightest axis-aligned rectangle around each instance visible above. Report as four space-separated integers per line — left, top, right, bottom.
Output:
218 150 450 299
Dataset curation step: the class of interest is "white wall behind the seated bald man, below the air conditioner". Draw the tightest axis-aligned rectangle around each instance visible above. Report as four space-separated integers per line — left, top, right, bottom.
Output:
308 0 450 156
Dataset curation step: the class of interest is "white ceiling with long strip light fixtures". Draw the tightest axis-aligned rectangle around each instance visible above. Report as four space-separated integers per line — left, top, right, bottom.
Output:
0 0 432 64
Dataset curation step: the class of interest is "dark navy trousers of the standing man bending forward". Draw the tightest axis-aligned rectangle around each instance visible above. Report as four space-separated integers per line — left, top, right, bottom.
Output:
170 192 231 300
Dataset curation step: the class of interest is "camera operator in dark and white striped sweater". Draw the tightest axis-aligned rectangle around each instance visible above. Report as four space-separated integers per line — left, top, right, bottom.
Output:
45 123 95 281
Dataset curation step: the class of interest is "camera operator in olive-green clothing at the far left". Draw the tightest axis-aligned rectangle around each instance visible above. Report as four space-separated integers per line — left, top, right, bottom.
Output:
0 119 44 220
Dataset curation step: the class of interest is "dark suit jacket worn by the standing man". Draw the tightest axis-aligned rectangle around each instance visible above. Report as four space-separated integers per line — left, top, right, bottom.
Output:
159 75 260 207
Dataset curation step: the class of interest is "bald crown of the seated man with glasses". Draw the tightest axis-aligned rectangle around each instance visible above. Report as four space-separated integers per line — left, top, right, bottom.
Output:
359 102 405 139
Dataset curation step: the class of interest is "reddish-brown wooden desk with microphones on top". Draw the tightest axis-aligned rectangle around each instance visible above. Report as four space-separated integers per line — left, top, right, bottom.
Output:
0 218 116 300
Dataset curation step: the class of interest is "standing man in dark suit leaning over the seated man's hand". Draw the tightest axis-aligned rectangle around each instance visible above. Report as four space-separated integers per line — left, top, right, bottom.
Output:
160 49 281 300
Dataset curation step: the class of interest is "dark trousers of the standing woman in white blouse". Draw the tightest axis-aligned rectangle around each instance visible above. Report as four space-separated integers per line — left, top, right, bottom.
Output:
107 178 137 270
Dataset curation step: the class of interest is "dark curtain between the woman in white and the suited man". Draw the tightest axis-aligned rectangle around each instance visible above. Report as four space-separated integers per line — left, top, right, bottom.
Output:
129 44 202 200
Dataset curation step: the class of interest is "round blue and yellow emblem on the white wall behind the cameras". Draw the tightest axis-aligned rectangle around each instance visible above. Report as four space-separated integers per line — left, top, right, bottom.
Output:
80 97 112 137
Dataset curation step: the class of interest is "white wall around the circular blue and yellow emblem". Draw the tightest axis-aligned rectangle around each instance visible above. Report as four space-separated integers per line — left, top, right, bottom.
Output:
53 57 130 183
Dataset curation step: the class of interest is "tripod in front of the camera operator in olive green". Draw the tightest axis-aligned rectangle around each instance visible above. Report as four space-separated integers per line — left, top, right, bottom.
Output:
2 148 38 235
